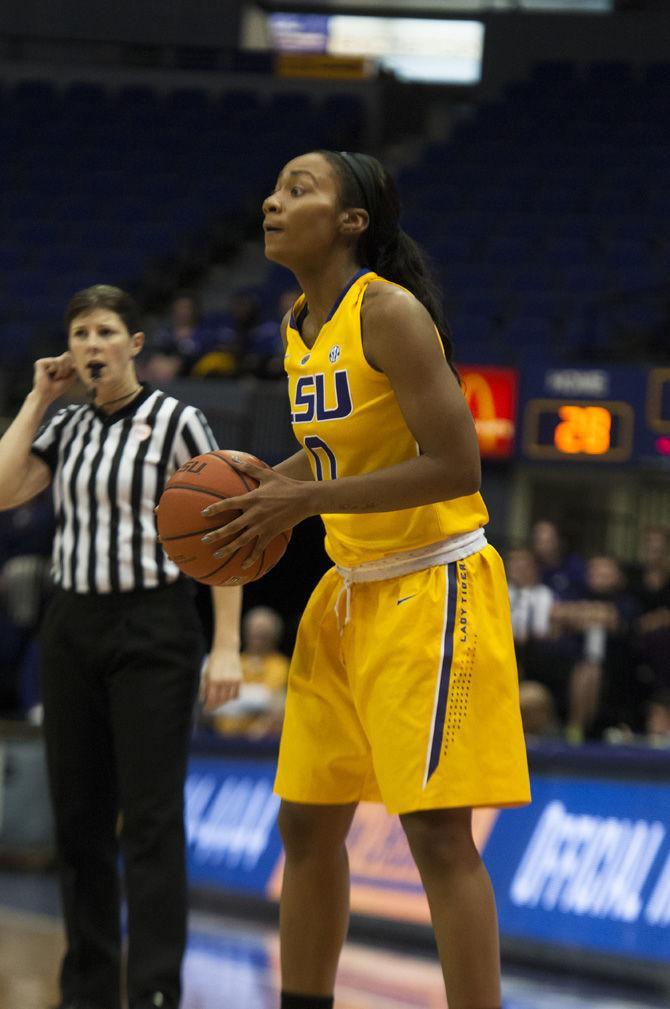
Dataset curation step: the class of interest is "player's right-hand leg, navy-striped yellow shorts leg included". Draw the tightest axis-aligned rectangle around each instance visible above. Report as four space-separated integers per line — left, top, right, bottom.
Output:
350 547 529 1009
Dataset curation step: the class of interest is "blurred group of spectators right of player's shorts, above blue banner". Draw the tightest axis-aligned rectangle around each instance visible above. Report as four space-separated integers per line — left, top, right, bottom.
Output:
507 521 670 746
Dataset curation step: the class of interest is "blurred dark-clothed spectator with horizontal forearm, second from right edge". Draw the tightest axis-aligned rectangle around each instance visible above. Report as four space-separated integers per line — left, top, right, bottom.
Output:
552 556 642 743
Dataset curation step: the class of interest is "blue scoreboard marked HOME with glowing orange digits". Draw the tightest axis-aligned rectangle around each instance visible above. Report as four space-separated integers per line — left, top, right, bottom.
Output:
517 365 670 468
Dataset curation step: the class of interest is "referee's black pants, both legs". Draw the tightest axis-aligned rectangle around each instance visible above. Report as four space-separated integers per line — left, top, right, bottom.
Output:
41 582 203 1009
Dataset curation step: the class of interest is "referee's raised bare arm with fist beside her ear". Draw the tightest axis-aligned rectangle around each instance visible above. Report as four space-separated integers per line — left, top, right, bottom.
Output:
0 353 77 511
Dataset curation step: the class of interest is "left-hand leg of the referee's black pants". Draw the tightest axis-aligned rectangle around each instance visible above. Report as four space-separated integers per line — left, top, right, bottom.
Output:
40 593 121 1009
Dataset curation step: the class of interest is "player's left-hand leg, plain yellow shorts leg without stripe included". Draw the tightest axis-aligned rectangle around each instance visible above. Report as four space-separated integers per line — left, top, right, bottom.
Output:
275 571 378 1009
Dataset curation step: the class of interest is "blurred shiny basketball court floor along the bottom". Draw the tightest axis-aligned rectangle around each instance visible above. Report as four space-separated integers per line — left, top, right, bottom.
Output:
0 872 668 1009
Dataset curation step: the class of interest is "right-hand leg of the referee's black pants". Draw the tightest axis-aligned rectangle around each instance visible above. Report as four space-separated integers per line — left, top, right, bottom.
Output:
110 585 202 1009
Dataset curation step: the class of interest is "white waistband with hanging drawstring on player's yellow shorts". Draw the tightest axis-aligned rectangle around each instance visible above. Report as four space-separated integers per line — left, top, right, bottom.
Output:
335 529 487 634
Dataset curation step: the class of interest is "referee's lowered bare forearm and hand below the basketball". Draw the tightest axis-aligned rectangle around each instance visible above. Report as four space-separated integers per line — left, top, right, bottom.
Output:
200 586 242 711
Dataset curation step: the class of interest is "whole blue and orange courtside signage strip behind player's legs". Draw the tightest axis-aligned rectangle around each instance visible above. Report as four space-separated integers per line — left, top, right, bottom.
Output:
186 757 670 967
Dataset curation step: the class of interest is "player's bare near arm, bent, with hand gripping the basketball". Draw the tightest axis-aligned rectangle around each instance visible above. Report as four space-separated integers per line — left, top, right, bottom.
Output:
198 285 480 563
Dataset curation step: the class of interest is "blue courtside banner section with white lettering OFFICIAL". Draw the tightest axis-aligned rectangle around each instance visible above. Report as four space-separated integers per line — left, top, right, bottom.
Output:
486 776 670 966
